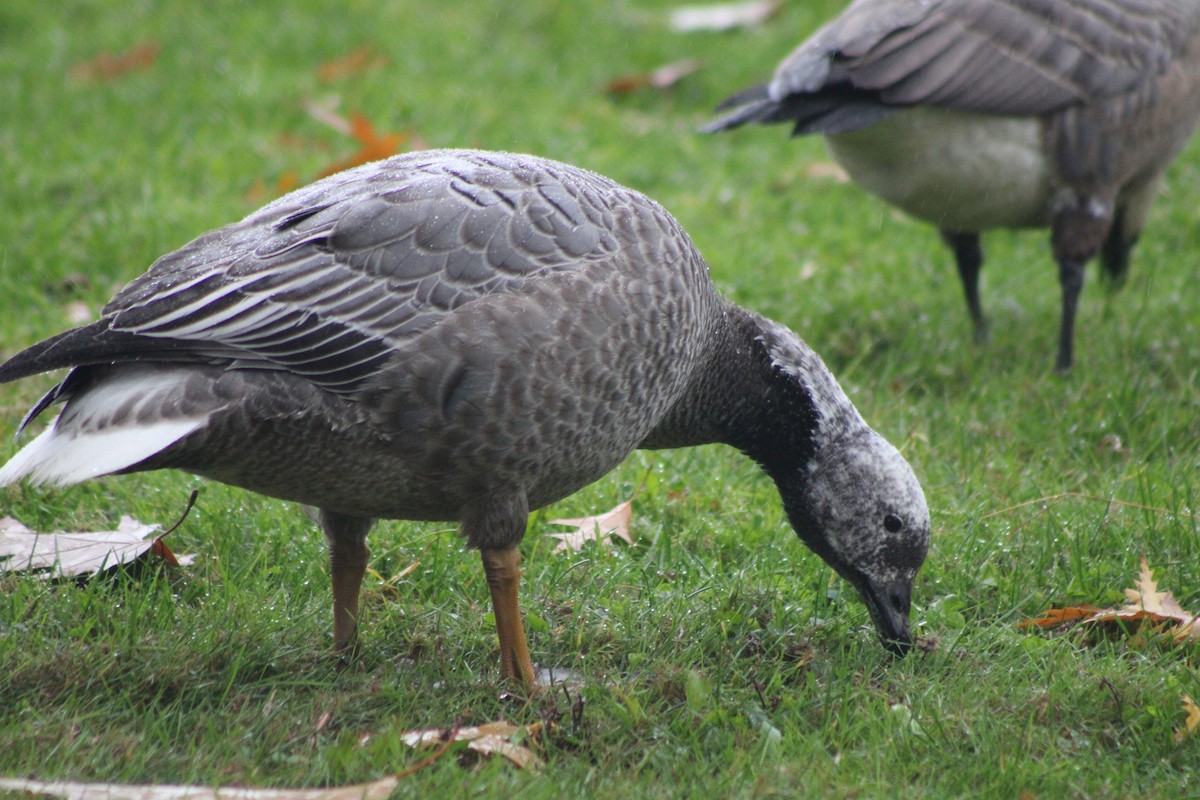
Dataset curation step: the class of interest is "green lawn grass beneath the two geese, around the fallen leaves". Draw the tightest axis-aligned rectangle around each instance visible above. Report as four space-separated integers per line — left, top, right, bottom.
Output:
0 0 1200 798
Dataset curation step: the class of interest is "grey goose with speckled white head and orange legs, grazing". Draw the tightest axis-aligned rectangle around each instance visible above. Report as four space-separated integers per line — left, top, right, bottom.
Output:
0 150 929 686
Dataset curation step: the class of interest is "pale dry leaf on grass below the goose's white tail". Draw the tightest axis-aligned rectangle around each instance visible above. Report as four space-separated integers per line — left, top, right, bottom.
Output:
0 517 196 579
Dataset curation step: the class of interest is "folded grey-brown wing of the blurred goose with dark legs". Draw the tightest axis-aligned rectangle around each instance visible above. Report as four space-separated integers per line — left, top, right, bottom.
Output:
767 0 1198 115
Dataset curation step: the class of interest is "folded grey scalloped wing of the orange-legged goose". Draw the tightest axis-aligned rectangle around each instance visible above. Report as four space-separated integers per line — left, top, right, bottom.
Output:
52 151 619 392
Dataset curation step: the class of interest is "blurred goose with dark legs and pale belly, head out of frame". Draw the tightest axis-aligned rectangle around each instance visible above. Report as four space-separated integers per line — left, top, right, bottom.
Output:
703 0 1200 371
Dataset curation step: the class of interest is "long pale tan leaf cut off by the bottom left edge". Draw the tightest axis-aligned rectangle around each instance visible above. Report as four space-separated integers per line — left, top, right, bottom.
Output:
0 775 401 800
